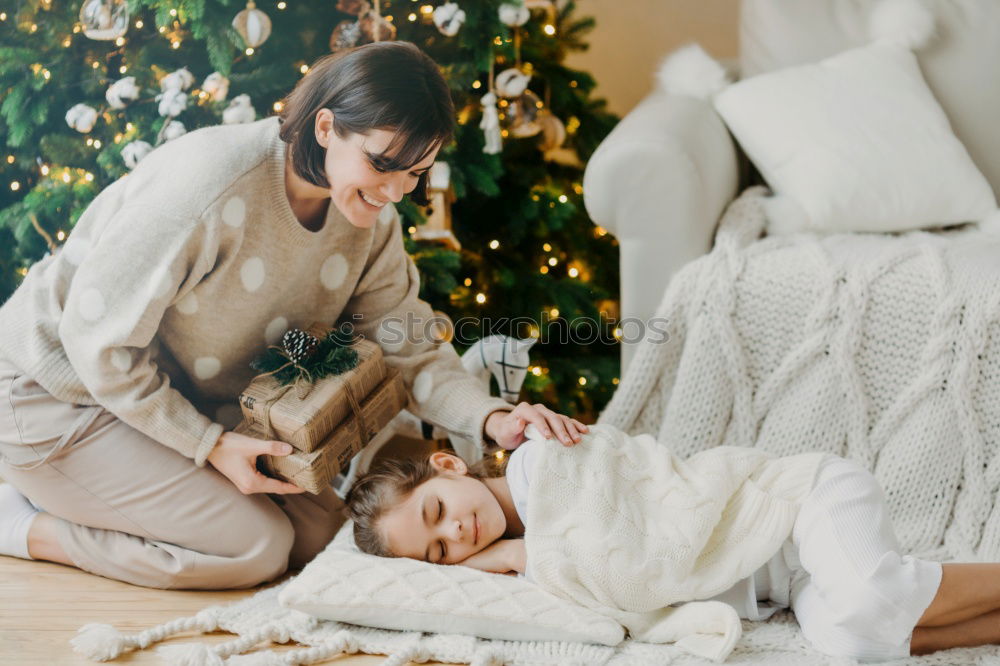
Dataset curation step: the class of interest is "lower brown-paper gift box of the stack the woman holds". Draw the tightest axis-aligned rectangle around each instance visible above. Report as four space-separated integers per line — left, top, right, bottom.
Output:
234 368 406 495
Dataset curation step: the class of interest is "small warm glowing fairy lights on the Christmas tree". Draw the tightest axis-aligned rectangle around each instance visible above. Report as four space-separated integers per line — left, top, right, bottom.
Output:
0 0 622 390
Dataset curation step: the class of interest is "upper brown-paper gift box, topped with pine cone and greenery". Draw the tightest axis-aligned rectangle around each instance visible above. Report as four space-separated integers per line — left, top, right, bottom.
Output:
240 324 386 453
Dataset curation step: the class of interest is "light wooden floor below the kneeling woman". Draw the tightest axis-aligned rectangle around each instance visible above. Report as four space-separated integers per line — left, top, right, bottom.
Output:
0 555 454 666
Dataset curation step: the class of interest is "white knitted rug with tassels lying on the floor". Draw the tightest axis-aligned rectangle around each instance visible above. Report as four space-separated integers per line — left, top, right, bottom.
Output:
71 581 1000 666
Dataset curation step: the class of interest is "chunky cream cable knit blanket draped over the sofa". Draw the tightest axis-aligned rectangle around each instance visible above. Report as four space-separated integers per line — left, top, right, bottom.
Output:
598 187 1000 561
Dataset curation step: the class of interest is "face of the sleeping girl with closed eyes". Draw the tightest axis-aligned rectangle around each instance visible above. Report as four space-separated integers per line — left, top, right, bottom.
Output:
378 451 507 564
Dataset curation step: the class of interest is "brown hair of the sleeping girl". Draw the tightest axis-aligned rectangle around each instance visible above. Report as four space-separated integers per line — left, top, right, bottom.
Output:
346 451 510 557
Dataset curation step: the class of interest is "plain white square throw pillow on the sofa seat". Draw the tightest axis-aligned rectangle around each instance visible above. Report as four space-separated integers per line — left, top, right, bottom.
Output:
714 31 997 234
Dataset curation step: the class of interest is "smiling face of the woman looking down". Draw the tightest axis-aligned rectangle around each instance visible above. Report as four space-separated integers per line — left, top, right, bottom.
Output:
316 109 440 228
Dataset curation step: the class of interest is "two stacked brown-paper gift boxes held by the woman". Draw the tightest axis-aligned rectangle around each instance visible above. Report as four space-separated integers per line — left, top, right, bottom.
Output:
234 324 406 494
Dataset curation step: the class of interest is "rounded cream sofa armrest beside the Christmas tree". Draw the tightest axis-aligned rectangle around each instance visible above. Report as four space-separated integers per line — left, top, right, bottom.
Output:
583 92 739 373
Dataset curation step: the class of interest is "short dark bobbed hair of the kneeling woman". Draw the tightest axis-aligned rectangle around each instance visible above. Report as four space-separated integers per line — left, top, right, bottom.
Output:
278 41 455 206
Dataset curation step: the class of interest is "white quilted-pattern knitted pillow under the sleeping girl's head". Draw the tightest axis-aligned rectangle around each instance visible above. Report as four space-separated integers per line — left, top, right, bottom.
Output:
278 521 625 646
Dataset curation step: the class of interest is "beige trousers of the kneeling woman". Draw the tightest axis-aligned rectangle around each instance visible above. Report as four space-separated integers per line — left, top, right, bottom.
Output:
0 358 346 589
